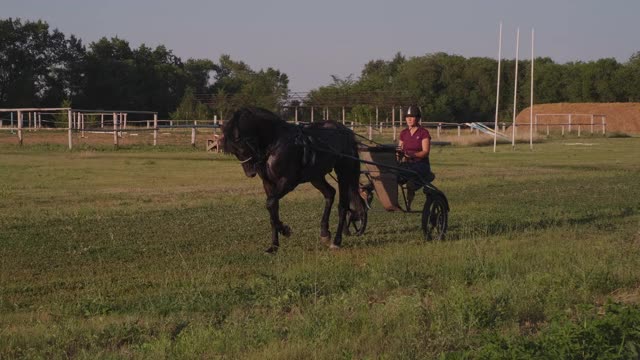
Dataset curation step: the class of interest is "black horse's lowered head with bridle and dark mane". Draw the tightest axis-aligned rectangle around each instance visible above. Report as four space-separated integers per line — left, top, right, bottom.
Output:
222 108 284 177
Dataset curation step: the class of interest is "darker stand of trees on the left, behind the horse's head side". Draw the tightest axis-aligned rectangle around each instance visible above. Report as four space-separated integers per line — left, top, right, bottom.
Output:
0 18 289 119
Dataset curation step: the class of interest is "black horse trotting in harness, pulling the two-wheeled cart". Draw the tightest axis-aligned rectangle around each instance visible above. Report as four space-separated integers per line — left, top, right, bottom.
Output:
222 108 365 253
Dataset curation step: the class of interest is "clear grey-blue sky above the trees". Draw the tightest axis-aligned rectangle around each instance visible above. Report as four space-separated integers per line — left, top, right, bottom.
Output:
5 0 640 92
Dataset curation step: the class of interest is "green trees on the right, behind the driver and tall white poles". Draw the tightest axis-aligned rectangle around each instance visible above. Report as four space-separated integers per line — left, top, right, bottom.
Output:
309 52 640 122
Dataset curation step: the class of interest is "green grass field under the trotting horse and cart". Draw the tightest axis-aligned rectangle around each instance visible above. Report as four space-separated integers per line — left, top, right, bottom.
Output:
0 138 640 359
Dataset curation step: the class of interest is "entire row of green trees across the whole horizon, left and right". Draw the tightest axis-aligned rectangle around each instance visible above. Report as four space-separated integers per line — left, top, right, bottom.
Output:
0 18 640 122
